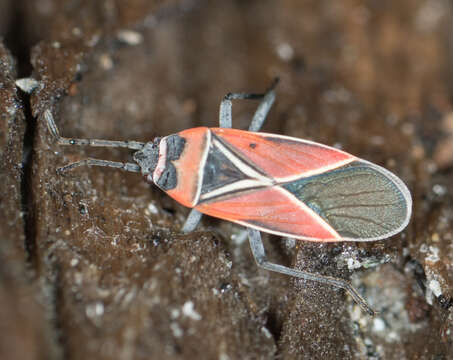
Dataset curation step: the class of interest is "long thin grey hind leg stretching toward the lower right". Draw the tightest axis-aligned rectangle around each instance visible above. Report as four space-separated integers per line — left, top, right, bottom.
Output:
248 228 376 316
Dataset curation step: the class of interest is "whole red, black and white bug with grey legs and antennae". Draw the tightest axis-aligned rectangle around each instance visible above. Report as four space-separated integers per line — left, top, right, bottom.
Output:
44 81 412 315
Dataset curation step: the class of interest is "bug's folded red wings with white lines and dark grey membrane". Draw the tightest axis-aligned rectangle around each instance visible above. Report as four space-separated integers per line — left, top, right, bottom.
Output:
196 129 412 241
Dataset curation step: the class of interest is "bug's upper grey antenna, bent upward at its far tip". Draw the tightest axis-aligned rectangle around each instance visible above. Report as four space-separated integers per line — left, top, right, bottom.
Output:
44 109 145 150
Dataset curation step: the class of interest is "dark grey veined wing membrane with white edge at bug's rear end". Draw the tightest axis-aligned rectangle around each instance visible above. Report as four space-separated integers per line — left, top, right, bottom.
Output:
282 160 412 241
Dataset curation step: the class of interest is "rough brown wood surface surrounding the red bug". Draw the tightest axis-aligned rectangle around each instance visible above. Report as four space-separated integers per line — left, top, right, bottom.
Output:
0 0 453 360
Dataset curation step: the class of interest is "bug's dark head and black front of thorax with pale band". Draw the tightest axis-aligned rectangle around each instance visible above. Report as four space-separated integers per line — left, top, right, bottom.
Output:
134 135 186 191
